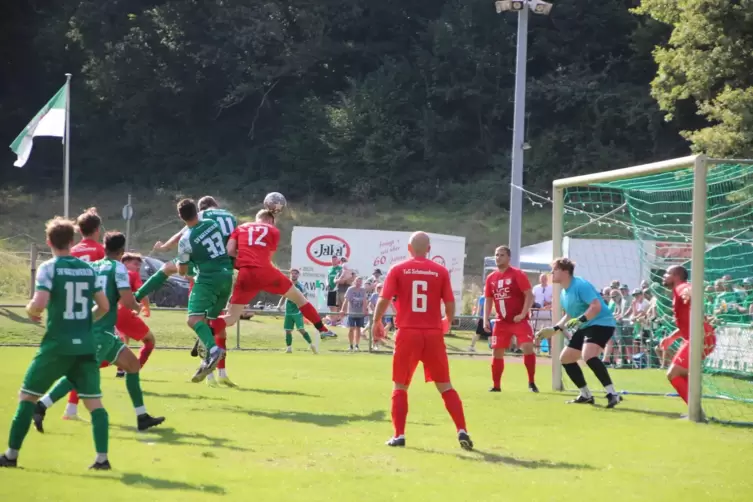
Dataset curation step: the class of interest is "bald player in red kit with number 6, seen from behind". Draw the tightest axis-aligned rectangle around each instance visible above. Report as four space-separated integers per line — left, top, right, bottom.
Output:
374 232 473 450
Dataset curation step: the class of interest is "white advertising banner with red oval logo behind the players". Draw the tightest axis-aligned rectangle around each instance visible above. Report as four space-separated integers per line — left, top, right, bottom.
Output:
290 227 465 311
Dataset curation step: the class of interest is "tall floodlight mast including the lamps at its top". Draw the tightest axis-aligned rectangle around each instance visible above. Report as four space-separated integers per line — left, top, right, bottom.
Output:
494 0 552 267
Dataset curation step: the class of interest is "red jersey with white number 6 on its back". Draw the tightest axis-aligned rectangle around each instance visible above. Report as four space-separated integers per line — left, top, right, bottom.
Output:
381 258 455 334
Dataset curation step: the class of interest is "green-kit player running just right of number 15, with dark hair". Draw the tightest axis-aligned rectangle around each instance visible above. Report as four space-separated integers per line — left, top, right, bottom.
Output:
34 232 165 432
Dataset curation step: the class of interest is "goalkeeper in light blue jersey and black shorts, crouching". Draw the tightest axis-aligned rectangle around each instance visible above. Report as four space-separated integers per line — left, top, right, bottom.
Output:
539 258 622 408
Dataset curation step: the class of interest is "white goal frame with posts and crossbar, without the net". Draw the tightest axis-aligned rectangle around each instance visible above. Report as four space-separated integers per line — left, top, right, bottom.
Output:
551 154 753 422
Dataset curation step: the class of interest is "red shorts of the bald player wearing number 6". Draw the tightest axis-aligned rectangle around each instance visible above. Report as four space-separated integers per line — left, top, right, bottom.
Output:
392 329 450 385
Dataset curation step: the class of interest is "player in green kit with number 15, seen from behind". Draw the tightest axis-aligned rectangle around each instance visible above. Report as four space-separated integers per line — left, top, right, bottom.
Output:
0 218 110 470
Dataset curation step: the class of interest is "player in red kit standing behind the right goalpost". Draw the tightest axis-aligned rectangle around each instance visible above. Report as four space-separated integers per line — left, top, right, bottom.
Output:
660 265 716 403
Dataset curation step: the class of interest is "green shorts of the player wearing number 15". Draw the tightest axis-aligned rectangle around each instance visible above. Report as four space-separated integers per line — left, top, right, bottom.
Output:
21 349 102 399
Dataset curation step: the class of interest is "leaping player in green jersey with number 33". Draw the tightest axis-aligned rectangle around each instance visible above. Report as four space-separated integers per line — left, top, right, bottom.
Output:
178 199 233 382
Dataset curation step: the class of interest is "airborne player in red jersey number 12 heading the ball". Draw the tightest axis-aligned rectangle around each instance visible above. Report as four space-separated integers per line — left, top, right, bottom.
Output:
220 209 335 337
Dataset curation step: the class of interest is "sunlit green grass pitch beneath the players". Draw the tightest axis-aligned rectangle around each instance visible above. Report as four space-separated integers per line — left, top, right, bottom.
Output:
0 309 753 502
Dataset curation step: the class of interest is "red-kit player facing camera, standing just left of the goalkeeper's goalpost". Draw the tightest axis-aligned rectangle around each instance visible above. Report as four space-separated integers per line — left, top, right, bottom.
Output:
484 246 539 392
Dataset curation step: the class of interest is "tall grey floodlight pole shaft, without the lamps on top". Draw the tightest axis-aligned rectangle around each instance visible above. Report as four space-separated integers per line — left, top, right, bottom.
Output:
508 2 529 267
